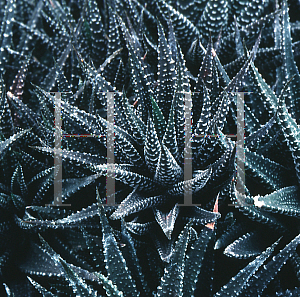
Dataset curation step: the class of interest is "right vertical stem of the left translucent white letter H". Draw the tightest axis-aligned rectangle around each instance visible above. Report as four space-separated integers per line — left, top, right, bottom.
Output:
104 92 116 206
